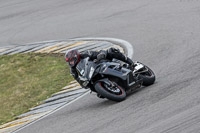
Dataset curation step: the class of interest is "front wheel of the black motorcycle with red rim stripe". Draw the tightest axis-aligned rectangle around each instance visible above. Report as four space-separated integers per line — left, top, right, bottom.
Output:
95 81 126 102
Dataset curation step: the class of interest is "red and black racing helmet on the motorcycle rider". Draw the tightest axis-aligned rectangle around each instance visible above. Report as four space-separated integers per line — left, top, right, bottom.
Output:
65 50 80 67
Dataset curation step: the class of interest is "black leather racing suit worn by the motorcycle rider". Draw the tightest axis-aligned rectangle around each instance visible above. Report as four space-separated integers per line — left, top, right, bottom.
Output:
71 48 133 85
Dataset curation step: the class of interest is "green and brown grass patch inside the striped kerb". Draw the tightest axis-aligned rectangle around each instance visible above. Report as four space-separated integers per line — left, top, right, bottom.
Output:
0 53 73 125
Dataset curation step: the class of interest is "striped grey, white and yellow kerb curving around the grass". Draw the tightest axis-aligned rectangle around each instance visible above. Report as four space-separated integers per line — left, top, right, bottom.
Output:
0 39 124 133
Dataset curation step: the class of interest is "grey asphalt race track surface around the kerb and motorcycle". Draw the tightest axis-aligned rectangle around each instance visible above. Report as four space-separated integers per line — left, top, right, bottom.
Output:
0 0 200 133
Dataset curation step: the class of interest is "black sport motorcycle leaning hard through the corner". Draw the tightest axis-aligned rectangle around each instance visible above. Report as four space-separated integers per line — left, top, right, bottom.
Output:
76 58 155 102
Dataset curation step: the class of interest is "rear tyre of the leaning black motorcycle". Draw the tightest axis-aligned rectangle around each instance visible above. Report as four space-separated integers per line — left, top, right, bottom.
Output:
139 66 156 86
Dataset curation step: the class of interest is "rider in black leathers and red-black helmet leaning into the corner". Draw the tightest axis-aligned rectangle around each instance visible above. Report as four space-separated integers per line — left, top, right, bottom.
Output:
65 48 134 96
